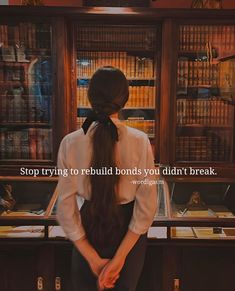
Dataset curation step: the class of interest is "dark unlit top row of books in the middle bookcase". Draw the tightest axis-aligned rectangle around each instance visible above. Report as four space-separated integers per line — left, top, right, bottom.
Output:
77 25 157 51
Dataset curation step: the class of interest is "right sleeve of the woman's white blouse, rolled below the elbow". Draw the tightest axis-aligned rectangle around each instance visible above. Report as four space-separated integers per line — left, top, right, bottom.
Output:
129 136 157 234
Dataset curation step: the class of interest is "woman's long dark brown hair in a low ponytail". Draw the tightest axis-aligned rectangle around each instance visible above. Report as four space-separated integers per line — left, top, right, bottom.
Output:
83 66 129 245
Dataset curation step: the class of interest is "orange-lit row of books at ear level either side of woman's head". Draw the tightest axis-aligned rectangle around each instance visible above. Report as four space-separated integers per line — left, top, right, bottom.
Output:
77 86 155 108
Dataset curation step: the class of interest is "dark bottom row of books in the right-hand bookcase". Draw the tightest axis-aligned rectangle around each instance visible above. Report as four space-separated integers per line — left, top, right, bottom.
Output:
176 132 231 162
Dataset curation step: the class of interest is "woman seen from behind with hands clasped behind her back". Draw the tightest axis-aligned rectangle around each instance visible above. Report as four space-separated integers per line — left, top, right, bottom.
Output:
57 67 156 291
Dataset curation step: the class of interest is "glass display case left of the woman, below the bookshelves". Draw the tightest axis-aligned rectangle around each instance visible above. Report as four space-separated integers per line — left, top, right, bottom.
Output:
0 176 57 239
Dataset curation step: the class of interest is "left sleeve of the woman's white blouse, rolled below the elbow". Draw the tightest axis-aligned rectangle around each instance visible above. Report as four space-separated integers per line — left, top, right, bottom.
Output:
57 138 85 241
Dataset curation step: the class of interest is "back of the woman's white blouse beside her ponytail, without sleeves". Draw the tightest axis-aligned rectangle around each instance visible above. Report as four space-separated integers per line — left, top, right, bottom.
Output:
58 118 153 204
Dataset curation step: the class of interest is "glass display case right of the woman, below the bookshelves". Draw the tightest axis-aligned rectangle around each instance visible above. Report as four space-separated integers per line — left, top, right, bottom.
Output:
168 181 235 240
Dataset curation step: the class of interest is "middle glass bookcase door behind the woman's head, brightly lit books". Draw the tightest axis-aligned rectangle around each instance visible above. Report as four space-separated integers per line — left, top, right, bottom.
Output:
76 24 159 156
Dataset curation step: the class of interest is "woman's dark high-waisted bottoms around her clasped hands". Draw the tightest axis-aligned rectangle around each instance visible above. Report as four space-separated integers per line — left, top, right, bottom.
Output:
68 202 147 291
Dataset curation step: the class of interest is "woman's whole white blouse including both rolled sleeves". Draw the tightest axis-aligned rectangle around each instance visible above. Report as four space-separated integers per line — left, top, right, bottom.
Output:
57 118 157 241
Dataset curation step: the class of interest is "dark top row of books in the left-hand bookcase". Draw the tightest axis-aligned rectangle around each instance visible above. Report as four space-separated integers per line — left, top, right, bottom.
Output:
0 22 51 49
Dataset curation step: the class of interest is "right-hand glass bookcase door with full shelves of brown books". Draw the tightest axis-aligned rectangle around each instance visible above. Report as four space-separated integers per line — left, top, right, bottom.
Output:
175 24 235 163
